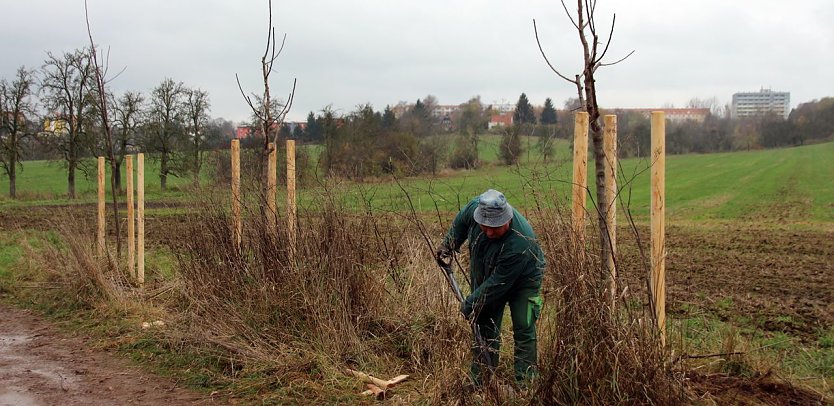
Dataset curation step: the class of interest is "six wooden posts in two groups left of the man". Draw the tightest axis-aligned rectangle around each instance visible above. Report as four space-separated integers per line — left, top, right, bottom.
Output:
96 140 297 286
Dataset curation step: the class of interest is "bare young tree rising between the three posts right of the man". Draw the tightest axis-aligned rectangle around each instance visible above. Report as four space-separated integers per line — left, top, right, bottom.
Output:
533 0 634 272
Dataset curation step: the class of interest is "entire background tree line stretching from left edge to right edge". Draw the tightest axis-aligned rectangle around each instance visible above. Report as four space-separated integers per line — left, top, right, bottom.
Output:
0 49 834 198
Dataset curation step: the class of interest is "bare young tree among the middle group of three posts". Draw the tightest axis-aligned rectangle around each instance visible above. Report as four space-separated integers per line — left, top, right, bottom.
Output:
235 0 296 181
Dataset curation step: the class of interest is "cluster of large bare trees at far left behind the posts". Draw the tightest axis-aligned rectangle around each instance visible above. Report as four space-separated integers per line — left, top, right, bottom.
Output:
0 48 234 198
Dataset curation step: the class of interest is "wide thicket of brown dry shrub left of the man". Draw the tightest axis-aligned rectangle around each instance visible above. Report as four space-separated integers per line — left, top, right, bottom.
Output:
172 185 469 400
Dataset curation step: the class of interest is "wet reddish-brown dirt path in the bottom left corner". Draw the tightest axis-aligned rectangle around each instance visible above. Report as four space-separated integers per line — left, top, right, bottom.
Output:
0 304 214 406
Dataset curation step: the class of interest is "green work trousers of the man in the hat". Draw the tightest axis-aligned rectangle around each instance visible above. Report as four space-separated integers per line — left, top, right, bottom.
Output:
470 277 542 385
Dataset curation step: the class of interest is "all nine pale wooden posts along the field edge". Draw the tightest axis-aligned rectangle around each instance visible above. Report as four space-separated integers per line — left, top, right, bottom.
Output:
98 112 666 344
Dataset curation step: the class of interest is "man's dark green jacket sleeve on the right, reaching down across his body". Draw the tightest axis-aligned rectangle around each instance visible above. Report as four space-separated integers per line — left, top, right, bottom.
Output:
462 249 530 314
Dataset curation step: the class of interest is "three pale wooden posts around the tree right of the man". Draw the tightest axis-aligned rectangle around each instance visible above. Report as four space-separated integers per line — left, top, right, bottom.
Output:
572 111 666 345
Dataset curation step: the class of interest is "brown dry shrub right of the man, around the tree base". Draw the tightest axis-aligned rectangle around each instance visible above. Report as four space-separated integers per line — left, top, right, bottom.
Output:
532 201 684 405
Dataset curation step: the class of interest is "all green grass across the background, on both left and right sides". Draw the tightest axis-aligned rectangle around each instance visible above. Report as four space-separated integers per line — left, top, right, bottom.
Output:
0 139 834 223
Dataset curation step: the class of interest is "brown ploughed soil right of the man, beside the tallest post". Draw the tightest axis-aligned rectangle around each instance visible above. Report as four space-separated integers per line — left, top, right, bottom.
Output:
620 223 834 341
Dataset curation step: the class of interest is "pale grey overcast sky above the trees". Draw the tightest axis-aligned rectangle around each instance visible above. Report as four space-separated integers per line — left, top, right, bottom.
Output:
0 0 834 121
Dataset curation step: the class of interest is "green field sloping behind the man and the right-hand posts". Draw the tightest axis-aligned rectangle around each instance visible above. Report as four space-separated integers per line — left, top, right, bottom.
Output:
328 139 834 222
